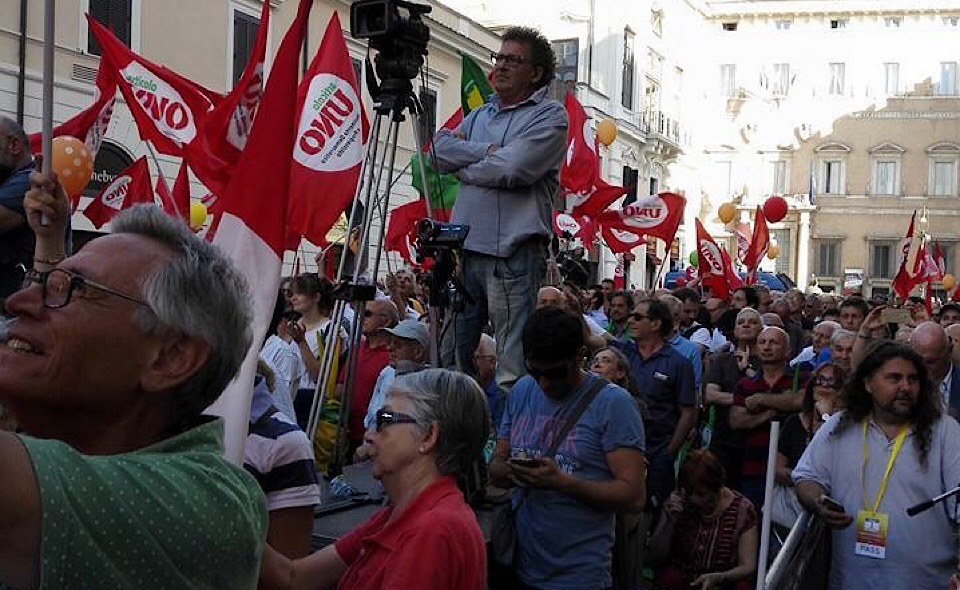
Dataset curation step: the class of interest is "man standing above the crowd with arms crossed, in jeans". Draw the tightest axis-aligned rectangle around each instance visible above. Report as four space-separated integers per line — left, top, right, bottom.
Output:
434 27 567 398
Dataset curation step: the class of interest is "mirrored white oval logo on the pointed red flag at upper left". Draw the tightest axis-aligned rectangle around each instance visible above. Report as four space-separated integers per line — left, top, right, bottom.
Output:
121 61 197 145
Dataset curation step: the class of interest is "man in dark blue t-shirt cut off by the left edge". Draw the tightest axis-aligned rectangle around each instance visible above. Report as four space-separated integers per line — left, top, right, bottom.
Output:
0 116 35 304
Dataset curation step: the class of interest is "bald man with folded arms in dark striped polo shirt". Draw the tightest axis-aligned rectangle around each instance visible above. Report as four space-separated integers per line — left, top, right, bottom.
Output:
730 326 805 506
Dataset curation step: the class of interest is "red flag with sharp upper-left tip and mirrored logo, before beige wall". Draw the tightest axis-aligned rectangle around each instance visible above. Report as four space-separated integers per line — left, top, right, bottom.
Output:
87 15 212 156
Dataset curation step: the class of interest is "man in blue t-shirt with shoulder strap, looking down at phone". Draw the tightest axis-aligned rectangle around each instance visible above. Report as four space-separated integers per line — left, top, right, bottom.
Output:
490 307 646 590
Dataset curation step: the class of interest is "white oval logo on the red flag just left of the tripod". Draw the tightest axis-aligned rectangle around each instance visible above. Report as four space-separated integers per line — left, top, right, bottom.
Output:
293 74 363 172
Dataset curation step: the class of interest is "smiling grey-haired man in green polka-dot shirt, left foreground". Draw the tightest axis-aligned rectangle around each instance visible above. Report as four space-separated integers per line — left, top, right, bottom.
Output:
0 173 267 588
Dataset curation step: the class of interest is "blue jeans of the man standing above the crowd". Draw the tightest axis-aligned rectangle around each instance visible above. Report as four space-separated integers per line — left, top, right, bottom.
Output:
440 238 546 392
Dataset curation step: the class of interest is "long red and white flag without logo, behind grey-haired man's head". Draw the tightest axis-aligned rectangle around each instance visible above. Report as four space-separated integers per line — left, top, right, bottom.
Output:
211 0 313 463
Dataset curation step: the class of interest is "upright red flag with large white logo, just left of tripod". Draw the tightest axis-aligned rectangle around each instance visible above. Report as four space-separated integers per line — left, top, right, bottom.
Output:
287 12 368 243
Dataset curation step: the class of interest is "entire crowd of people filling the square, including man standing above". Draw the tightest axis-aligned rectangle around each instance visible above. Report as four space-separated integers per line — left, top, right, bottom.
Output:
0 20 960 590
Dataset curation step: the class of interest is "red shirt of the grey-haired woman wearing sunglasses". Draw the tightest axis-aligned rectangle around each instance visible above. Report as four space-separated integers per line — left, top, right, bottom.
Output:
335 477 487 590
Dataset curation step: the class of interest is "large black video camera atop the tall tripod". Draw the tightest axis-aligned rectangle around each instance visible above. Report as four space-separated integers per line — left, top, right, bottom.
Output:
350 0 433 80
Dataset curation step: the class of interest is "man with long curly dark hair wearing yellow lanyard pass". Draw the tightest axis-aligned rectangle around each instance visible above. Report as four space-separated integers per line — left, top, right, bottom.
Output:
793 341 960 590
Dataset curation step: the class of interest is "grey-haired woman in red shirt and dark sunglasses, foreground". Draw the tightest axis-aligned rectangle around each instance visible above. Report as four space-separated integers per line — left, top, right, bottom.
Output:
261 369 490 590
